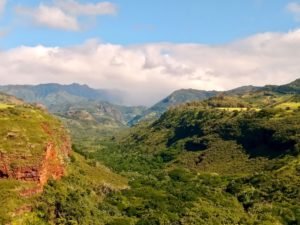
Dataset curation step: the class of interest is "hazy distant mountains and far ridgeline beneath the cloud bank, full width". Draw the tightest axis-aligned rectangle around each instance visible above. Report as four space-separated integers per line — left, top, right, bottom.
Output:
0 79 300 128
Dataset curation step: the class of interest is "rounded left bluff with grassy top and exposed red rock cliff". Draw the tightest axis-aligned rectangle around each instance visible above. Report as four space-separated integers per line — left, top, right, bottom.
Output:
0 94 71 224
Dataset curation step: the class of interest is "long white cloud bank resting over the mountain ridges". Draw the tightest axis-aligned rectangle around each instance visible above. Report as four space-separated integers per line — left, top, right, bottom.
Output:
0 30 300 105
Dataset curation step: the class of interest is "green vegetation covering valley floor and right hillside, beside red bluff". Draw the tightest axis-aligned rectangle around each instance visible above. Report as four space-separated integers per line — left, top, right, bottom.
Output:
0 81 300 225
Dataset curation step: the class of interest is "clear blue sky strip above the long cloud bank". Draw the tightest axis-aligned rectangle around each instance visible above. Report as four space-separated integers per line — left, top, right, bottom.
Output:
0 0 300 49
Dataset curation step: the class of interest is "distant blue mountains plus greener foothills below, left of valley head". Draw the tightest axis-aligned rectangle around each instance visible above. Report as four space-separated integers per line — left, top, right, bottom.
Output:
0 84 145 136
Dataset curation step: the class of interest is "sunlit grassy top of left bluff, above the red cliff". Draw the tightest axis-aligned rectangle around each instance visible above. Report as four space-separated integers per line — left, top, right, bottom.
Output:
0 105 65 166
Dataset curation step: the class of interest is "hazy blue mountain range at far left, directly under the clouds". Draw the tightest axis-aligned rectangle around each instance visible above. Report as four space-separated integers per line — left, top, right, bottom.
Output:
0 83 145 124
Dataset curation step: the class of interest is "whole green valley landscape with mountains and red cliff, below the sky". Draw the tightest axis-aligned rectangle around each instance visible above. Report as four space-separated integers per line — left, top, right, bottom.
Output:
0 79 300 225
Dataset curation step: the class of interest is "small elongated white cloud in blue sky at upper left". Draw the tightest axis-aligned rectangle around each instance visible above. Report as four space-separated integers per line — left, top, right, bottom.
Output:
15 0 117 31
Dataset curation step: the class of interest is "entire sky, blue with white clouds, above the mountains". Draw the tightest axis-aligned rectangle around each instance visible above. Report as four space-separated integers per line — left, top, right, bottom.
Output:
0 0 300 105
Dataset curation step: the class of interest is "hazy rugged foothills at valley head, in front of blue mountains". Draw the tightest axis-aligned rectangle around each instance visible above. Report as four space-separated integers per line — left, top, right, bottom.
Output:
54 99 145 139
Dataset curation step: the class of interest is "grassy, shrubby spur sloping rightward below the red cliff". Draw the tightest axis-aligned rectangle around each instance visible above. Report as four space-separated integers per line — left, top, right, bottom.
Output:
6 153 127 225
